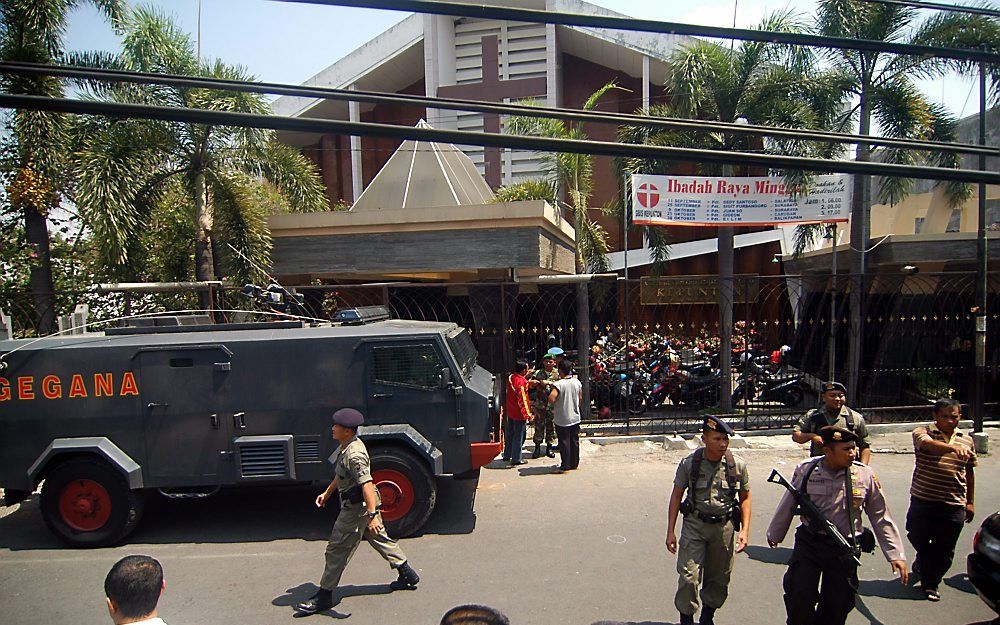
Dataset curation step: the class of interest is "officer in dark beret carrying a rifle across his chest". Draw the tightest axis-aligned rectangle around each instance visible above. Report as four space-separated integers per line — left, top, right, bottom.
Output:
767 426 909 625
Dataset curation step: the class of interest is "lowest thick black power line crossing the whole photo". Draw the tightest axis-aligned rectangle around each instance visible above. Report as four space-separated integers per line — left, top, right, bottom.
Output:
0 94 1000 184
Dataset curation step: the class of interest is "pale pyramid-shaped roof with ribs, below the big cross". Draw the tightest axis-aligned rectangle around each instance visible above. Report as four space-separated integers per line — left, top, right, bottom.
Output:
351 120 494 213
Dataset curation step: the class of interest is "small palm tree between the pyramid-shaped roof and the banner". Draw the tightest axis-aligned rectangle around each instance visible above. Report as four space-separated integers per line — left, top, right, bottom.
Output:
505 81 620 273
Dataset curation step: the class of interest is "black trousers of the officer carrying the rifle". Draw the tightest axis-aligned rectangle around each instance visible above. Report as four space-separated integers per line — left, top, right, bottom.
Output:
783 526 858 625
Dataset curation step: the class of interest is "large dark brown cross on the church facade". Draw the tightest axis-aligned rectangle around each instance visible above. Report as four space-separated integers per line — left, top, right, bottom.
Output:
437 35 547 189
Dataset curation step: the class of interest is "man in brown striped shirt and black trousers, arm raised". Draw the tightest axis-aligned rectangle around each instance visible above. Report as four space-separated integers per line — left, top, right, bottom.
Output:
906 399 976 601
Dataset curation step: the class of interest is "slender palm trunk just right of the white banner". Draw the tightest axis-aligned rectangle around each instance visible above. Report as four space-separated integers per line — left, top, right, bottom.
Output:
844 87 872 404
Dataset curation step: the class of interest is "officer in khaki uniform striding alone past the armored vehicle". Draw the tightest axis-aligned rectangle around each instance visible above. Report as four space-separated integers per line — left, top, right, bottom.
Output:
296 408 420 616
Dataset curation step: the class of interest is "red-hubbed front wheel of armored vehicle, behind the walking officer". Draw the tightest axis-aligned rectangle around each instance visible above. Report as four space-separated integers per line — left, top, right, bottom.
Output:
371 447 437 538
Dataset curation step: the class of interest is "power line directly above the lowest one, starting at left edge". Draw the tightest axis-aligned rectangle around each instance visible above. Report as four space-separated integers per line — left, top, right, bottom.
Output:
0 62 1000 156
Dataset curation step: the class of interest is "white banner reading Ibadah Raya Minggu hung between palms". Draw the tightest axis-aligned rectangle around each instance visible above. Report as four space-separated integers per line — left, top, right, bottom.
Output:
632 174 852 226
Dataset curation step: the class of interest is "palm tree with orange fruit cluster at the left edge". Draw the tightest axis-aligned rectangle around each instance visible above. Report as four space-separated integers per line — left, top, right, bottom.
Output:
0 0 125 334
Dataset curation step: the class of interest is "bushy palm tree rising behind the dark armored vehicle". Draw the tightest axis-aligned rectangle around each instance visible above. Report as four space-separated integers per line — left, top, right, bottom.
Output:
73 8 327 307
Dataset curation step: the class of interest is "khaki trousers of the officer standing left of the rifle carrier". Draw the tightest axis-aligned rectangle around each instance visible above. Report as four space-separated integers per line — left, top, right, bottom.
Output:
674 514 735 614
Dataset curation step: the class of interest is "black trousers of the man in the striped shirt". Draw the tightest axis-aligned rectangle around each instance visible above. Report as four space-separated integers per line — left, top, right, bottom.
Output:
906 497 965 590
